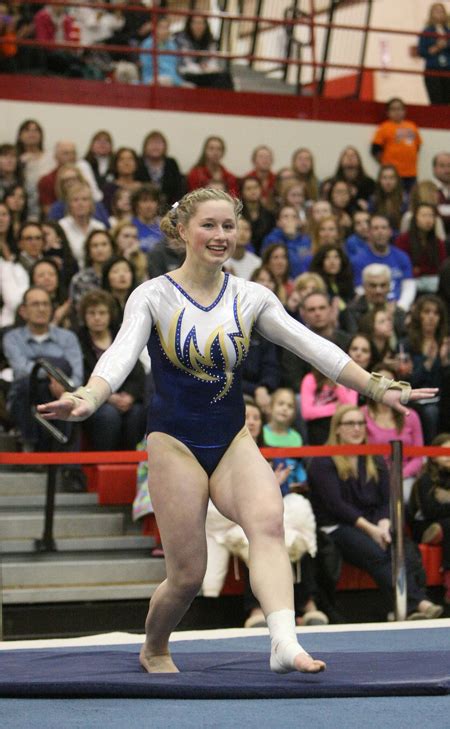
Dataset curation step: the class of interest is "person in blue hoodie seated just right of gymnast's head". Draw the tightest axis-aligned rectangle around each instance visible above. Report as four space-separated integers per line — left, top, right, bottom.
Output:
260 205 311 278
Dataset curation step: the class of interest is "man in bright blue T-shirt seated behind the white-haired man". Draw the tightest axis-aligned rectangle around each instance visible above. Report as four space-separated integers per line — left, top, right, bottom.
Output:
352 214 416 311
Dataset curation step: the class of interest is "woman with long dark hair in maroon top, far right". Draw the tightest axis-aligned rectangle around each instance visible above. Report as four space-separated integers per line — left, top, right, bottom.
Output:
395 203 447 291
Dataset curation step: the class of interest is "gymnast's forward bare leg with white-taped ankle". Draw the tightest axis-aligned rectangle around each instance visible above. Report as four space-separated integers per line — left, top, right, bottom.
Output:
210 429 325 673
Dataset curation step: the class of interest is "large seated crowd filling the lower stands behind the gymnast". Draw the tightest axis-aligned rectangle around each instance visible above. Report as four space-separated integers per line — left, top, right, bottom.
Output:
0 99 450 617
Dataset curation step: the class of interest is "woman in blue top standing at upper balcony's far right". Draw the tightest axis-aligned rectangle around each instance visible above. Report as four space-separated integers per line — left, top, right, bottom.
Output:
418 3 450 104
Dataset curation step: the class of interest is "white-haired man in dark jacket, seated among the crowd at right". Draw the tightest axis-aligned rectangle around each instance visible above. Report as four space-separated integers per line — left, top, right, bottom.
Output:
339 263 406 337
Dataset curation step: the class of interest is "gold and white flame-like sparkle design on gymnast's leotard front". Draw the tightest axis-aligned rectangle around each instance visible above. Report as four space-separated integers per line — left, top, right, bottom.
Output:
156 295 253 401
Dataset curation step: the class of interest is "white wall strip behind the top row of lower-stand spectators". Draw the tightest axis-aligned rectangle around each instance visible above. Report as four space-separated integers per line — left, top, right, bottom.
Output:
0 100 450 178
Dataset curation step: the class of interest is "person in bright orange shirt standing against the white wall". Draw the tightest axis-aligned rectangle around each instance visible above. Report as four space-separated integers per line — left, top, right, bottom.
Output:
371 98 422 192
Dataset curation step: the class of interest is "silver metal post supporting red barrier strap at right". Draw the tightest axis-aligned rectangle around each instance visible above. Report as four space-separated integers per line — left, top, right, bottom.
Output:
390 440 407 620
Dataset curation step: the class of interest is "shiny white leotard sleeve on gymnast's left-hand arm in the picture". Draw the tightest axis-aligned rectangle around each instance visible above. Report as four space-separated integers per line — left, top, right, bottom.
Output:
92 281 157 392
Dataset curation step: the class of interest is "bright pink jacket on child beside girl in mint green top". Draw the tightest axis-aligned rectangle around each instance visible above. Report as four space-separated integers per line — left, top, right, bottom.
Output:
300 372 358 420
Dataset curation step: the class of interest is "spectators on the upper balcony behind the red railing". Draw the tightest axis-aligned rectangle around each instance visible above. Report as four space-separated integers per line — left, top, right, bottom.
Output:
0 0 450 101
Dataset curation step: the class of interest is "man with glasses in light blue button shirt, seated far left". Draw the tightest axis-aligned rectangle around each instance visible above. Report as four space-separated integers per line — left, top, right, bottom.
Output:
3 286 83 460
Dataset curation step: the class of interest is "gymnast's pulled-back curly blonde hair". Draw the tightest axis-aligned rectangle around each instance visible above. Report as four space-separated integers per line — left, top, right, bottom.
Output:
160 187 242 249
